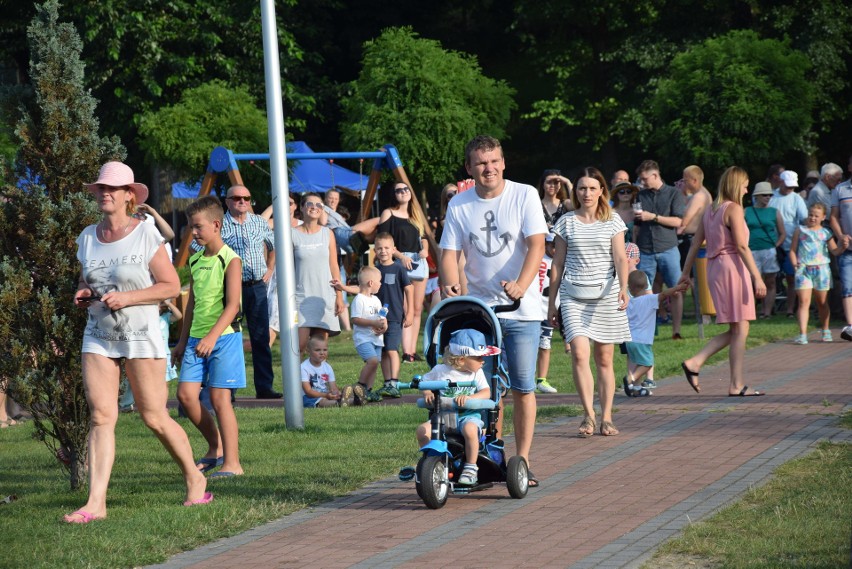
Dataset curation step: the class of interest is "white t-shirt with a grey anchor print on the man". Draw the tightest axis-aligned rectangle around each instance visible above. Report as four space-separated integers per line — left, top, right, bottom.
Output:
441 180 547 321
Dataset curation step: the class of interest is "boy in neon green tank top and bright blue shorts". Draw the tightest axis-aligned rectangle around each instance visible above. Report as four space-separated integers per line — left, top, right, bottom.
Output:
172 196 246 478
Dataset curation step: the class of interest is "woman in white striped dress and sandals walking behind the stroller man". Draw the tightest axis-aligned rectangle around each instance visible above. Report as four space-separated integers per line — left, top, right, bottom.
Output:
547 167 630 438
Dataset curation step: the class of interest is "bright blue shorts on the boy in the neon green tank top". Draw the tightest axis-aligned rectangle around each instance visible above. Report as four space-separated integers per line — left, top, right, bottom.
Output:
178 332 246 389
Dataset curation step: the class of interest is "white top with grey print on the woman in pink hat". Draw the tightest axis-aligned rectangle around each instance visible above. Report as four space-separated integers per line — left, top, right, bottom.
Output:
77 223 168 359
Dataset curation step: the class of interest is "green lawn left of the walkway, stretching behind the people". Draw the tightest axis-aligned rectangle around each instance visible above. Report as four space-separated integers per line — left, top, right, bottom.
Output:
0 310 850 568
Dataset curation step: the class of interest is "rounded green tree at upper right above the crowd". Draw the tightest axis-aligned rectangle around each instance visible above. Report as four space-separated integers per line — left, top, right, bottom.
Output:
651 30 813 169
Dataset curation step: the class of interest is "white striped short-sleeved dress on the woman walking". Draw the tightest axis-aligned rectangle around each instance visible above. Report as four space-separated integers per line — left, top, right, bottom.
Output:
553 212 630 344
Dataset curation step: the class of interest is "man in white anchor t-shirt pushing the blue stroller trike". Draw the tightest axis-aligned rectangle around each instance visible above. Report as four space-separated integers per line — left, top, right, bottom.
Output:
440 135 547 487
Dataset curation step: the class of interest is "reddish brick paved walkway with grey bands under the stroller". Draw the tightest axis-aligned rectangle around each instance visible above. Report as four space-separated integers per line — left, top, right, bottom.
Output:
150 341 852 569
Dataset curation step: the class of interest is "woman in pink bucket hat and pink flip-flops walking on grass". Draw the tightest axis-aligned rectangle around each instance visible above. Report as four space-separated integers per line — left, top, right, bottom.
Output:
65 162 213 524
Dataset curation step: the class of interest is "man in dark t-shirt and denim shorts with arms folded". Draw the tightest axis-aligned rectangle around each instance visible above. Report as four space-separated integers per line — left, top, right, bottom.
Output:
633 160 686 340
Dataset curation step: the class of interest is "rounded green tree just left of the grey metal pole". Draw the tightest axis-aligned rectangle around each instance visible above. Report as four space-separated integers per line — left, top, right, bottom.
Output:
139 80 269 177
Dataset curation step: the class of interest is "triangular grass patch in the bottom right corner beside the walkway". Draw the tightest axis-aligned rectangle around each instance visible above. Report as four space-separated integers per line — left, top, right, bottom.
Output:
643 442 852 569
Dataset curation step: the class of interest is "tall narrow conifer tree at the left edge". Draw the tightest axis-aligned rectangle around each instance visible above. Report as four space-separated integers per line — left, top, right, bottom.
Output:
0 0 124 488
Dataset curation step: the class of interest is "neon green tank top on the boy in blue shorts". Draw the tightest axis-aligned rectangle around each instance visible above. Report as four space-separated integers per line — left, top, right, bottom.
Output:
189 245 242 338
